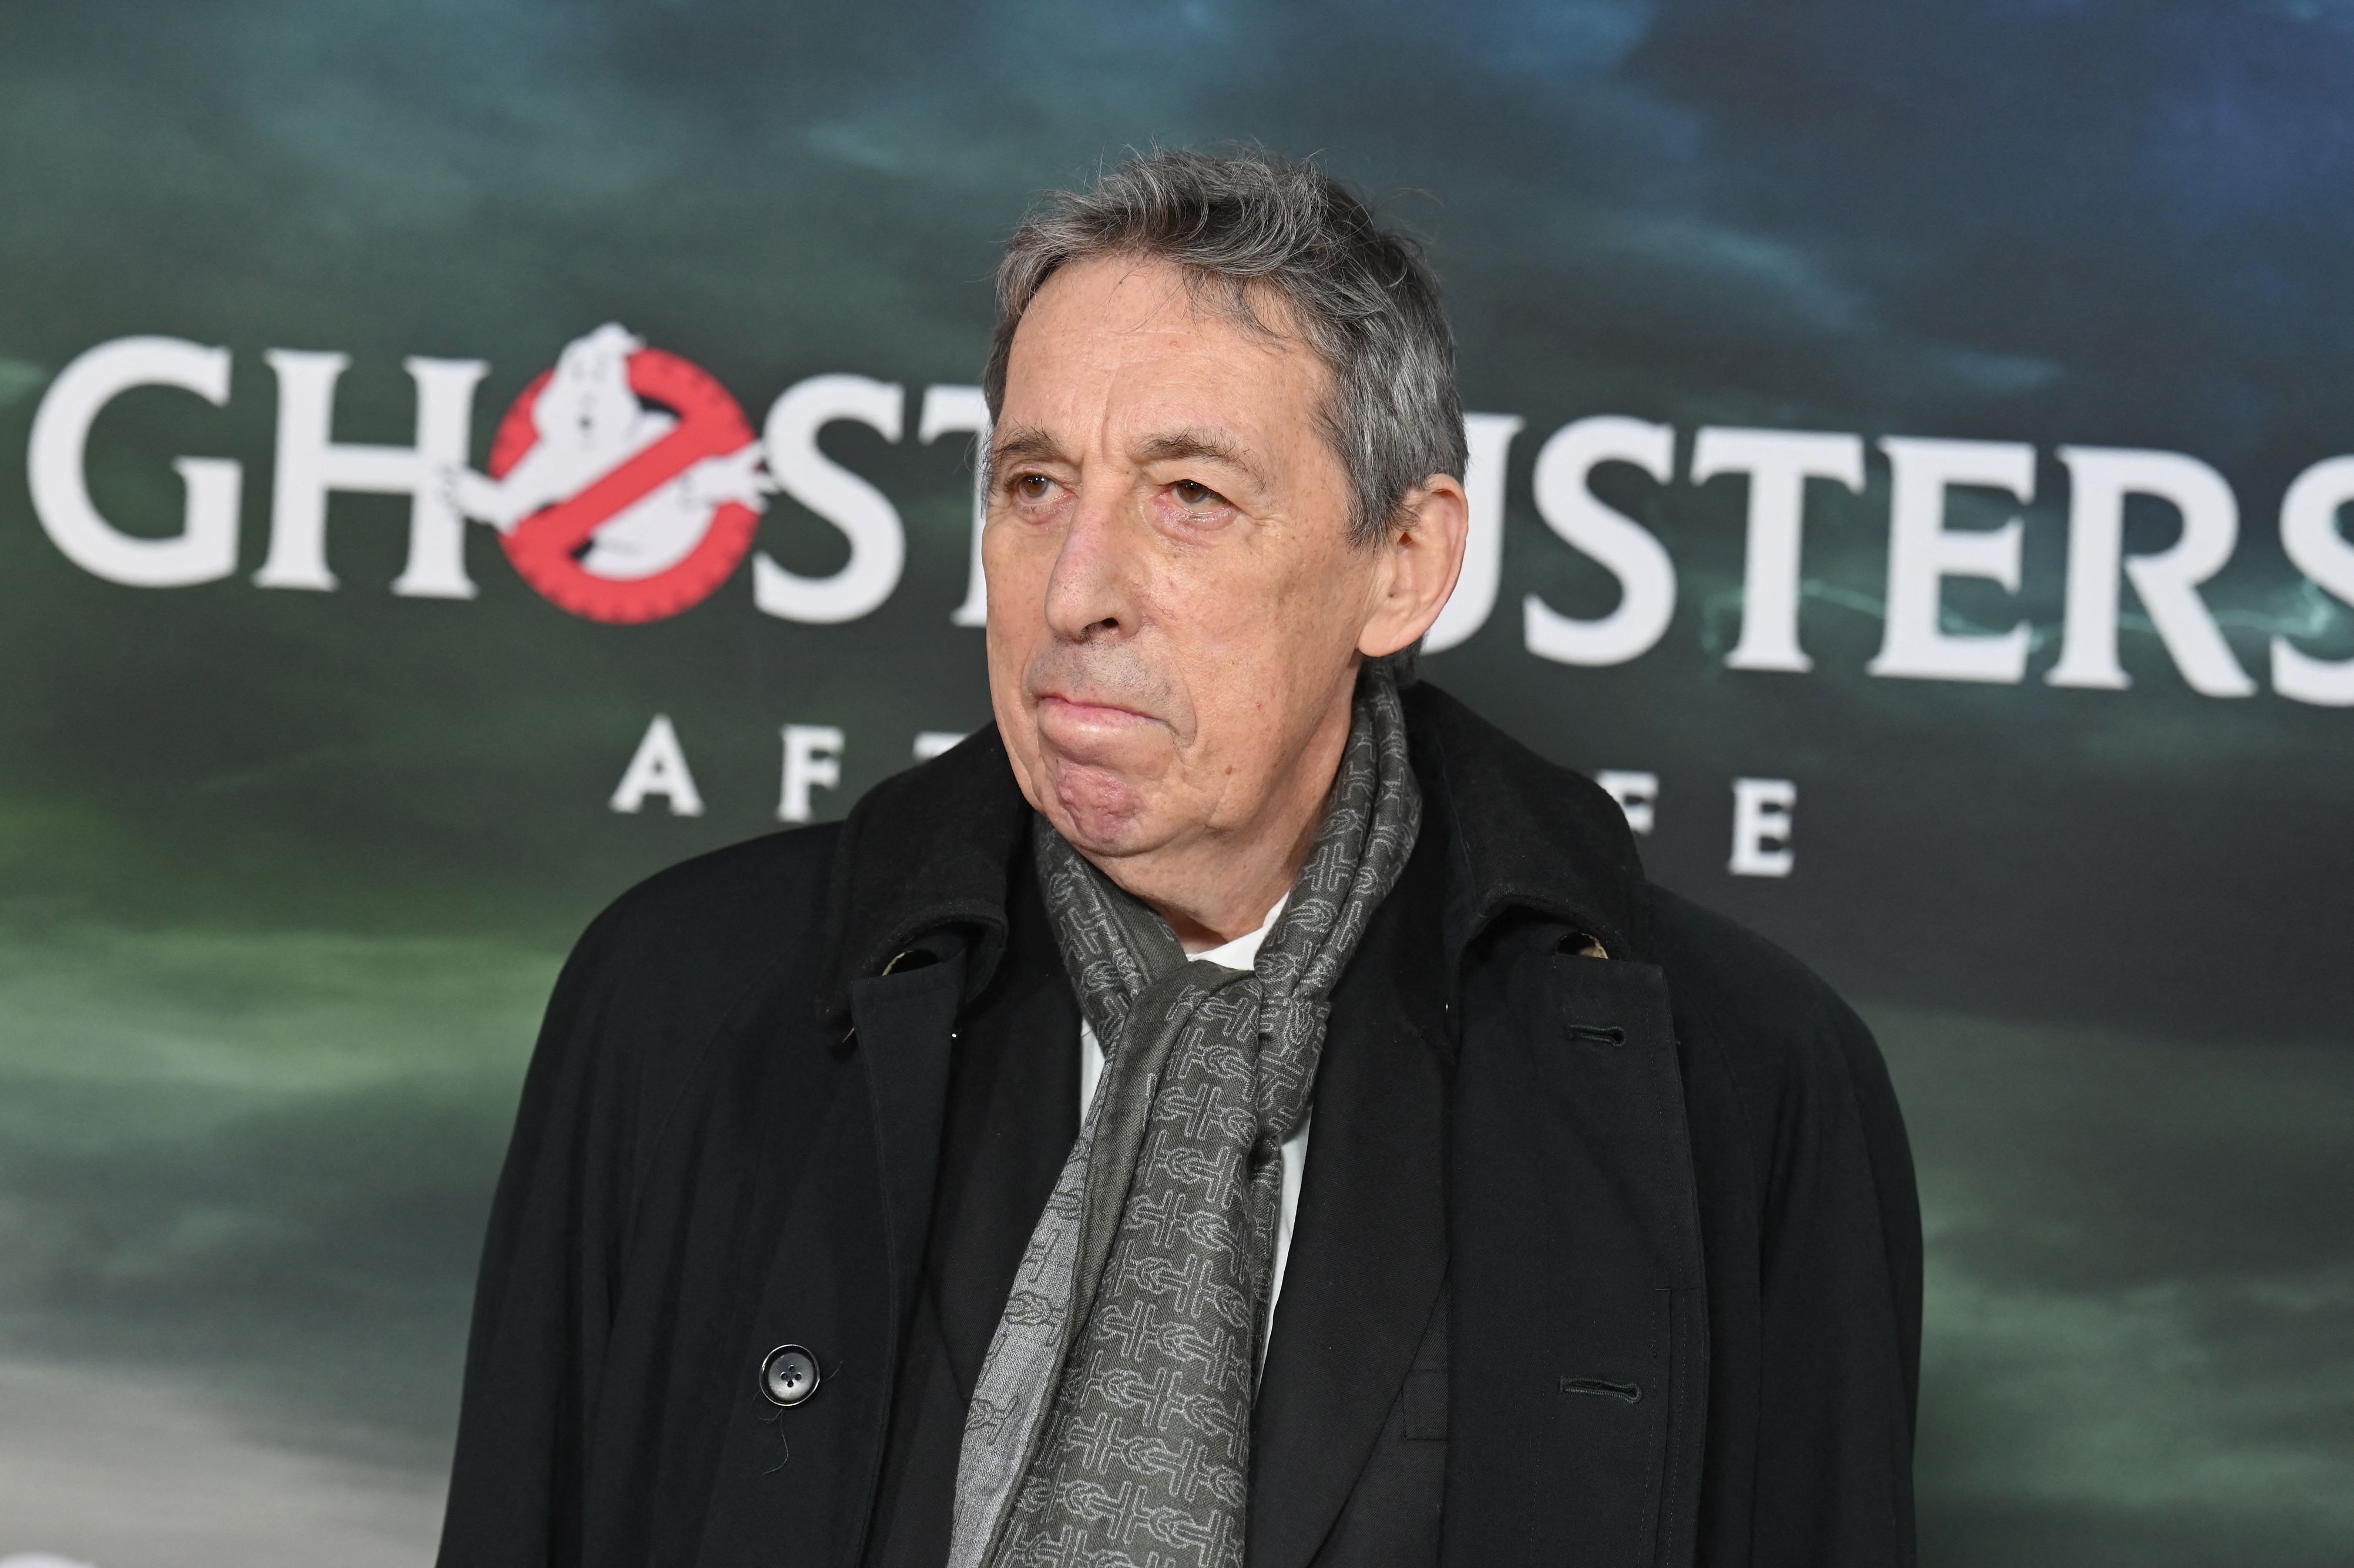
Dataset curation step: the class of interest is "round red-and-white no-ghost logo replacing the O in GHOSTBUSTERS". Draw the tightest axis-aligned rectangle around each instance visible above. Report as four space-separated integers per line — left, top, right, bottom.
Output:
449 323 777 624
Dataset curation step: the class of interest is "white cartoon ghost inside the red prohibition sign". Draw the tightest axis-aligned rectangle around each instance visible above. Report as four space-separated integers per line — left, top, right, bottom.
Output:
447 323 777 582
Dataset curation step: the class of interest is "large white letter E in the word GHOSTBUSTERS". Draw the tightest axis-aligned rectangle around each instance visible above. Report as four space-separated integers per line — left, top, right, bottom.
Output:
1865 435 2036 680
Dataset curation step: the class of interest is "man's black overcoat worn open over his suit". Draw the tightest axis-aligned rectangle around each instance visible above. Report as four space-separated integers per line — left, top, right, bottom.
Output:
440 685 1921 1568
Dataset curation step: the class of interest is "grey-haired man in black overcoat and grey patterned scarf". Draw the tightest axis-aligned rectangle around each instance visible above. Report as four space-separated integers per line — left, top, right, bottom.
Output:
442 153 1921 1568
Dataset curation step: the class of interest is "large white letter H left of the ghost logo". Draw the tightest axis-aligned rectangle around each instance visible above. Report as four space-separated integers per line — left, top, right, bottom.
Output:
254 348 489 598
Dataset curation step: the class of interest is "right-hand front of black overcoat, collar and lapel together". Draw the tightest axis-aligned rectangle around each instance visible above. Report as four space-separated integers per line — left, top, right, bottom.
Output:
1408 687 1709 1568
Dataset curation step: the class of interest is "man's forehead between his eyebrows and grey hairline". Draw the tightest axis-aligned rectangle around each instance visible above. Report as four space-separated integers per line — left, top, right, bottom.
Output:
1000 257 1330 445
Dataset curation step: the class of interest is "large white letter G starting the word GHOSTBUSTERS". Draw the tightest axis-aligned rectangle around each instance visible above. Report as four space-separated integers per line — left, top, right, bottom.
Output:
26 337 243 589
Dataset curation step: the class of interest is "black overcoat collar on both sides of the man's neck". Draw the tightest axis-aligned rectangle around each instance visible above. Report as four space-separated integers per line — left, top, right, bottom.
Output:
819 683 1650 1019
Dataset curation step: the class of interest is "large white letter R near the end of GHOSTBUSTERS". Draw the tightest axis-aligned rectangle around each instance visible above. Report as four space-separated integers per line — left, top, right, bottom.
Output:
2046 447 2255 697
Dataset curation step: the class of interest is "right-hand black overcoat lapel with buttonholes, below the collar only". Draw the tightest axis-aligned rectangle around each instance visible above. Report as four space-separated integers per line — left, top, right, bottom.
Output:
1443 923 1707 1568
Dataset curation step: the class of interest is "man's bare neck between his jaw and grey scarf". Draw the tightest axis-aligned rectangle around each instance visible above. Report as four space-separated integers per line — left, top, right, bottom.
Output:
1087 683 1354 953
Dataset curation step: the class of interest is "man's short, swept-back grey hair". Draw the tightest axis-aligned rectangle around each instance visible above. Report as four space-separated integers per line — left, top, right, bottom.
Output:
982 148 1466 544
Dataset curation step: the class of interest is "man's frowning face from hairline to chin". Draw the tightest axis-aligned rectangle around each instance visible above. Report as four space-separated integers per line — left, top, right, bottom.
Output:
982 259 1384 859
